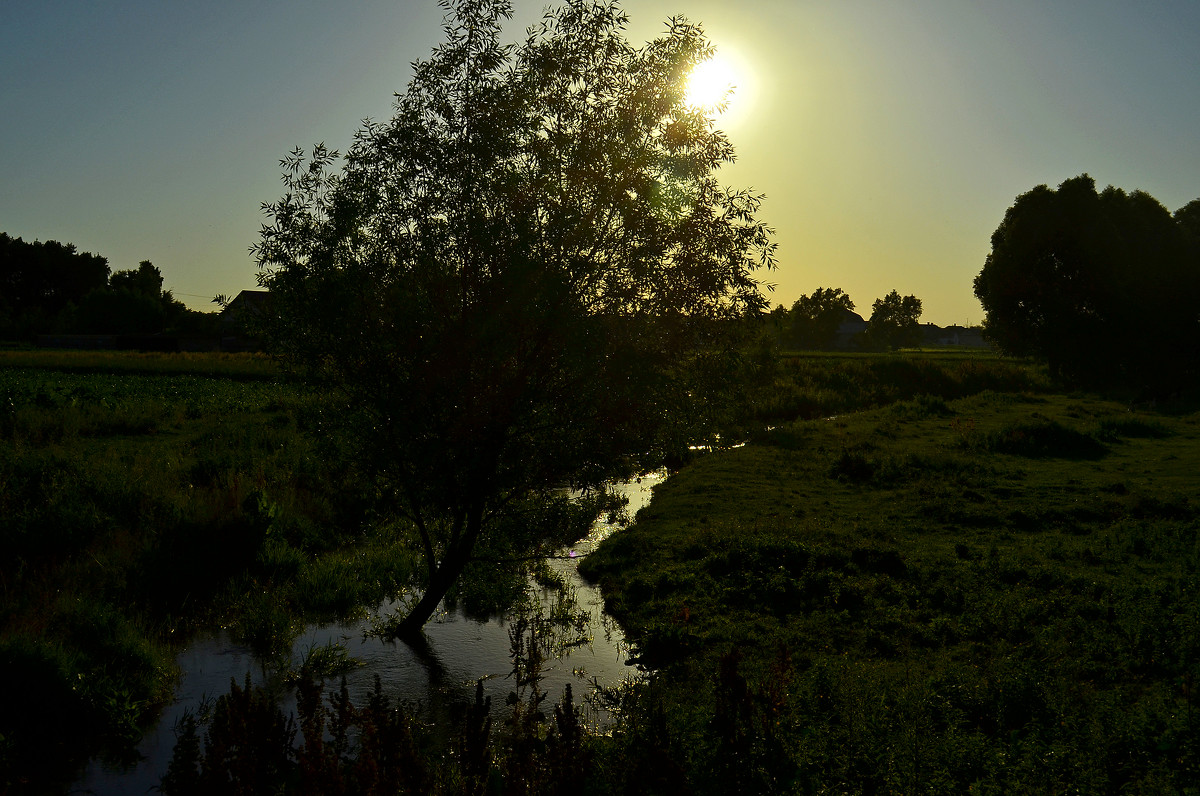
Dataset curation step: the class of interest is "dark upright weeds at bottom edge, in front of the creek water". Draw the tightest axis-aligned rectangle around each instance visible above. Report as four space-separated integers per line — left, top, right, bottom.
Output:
160 605 595 796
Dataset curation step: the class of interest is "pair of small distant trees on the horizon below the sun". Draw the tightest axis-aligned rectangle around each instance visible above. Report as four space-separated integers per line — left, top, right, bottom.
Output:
770 287 924 351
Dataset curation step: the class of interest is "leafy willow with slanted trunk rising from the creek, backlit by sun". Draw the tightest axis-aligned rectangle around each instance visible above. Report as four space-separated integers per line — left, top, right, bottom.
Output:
254 0 774 635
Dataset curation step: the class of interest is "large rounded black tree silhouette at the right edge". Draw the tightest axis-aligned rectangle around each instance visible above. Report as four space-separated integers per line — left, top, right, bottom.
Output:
974 174 1200 393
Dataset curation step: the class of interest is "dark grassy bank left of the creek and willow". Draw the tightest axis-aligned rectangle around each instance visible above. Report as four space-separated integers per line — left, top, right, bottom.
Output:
0 351 409 790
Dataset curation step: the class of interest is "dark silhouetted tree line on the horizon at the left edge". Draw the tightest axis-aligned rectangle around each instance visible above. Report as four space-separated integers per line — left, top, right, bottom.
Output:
0 233 215 340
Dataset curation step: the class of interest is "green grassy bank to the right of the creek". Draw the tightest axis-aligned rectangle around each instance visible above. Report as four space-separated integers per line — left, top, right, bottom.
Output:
582 376 1200 794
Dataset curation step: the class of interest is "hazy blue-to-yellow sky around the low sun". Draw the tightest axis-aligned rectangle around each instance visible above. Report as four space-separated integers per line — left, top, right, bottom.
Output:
0 0 1200 325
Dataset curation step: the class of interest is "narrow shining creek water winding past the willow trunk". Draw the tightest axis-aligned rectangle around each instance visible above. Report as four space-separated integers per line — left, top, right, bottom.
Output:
71 472 665 796
